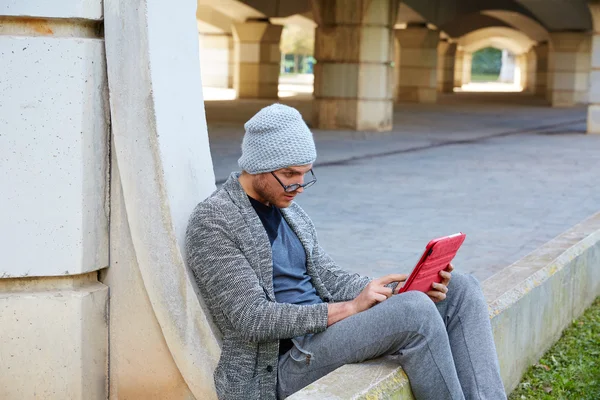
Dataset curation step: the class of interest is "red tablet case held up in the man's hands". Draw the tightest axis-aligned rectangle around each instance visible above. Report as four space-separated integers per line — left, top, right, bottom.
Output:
399 233 467 293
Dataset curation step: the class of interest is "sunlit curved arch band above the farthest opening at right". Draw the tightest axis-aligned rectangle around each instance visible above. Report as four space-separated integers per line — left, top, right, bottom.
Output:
458 27 535 55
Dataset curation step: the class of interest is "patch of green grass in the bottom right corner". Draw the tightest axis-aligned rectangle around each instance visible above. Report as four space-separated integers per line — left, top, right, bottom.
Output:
509 297 600 400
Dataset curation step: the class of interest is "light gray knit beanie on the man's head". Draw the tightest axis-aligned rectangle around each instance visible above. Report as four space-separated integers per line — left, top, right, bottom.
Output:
238 104 317 174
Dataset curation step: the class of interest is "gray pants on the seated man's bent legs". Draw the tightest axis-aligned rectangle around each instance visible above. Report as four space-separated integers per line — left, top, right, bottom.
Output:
277 272 506 400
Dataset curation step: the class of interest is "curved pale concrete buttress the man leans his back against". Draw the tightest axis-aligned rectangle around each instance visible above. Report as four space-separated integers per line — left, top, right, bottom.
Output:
104 0 220 399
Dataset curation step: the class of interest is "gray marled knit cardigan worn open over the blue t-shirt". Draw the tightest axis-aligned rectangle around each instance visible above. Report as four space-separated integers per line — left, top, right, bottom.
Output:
186 173 369 400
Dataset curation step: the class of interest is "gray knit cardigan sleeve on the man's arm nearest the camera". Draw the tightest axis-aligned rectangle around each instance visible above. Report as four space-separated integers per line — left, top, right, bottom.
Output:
186 204 328 341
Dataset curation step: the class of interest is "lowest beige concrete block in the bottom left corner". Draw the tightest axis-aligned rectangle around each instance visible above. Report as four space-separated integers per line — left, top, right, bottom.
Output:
0 272 108 400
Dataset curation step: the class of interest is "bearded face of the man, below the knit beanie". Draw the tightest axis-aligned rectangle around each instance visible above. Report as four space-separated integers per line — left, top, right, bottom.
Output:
252 164 312 208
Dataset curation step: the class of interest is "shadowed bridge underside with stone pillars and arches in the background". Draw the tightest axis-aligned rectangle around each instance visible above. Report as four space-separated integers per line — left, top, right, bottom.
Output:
196 0 600 132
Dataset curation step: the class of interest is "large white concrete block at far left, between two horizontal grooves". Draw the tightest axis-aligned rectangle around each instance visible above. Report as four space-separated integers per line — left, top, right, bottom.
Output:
0 35 109 277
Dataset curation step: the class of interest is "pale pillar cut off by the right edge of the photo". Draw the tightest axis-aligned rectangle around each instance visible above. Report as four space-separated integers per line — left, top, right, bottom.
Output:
587 0 600 134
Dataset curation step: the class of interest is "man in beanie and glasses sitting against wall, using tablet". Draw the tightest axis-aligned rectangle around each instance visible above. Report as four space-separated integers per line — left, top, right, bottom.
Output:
186 104 506 400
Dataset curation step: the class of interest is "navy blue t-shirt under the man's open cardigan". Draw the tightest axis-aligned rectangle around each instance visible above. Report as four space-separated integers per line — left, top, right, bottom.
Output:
248 196 323 305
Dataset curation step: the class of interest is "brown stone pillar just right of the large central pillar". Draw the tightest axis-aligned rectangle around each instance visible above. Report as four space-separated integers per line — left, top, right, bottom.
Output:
395 24 440 103
